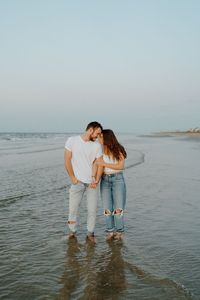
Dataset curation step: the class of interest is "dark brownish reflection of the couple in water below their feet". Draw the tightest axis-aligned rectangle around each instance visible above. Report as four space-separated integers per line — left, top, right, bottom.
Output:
58 240 127 300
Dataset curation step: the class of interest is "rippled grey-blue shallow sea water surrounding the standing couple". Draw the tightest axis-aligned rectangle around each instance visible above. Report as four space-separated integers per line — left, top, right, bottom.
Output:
0 134 200 300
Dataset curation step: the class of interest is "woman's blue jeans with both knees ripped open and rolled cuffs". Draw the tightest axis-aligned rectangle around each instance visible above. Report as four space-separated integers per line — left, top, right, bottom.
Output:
101 172 126 232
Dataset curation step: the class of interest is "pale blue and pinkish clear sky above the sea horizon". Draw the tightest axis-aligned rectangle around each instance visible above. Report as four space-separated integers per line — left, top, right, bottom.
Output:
0 0 200 133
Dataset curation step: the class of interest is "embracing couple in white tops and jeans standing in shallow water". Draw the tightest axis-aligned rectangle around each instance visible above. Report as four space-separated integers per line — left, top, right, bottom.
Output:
64 121 127 243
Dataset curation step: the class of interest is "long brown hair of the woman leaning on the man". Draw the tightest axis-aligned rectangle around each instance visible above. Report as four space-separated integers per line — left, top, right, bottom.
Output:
102 129 127 160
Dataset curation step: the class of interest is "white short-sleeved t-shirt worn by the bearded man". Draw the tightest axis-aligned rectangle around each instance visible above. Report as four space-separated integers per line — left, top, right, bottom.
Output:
65 135 102 183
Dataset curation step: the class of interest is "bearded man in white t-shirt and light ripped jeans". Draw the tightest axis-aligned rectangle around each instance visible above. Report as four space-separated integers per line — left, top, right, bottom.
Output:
64 121 103 243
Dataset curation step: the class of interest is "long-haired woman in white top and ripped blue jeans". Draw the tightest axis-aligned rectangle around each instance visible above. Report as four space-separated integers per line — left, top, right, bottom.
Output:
96 129 127 240
